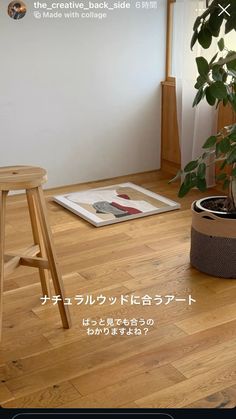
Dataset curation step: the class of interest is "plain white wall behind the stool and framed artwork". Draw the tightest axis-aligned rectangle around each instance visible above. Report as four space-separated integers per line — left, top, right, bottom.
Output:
0 0 166 186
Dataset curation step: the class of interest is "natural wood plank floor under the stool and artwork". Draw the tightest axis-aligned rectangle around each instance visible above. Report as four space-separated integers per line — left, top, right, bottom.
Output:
0 172 236 408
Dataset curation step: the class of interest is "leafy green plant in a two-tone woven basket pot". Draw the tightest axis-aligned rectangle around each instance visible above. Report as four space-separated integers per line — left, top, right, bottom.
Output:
173 0 236 278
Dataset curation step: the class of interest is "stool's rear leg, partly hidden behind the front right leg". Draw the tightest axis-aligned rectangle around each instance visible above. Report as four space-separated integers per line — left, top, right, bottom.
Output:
26 189 50 297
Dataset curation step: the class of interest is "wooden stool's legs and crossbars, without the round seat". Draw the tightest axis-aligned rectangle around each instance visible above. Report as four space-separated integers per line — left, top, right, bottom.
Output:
0 186 71 338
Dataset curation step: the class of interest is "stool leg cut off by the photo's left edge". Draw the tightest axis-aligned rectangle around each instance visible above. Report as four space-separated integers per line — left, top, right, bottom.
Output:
0 191 8 340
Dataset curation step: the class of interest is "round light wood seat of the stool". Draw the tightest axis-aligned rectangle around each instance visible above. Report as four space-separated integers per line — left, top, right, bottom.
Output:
0 166 47 191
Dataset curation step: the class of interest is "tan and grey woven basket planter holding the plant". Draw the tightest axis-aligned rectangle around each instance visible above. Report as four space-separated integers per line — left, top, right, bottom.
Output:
190 202 236 279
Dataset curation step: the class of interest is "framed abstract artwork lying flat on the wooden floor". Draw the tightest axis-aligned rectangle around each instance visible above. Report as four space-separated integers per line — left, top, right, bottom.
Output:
53 182 180 227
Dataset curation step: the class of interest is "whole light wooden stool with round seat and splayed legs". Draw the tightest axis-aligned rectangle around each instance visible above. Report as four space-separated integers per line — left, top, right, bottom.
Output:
0 166 71 338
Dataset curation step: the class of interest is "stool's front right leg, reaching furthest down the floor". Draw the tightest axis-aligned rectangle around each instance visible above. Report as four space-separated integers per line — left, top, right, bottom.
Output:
31 186 71 329
